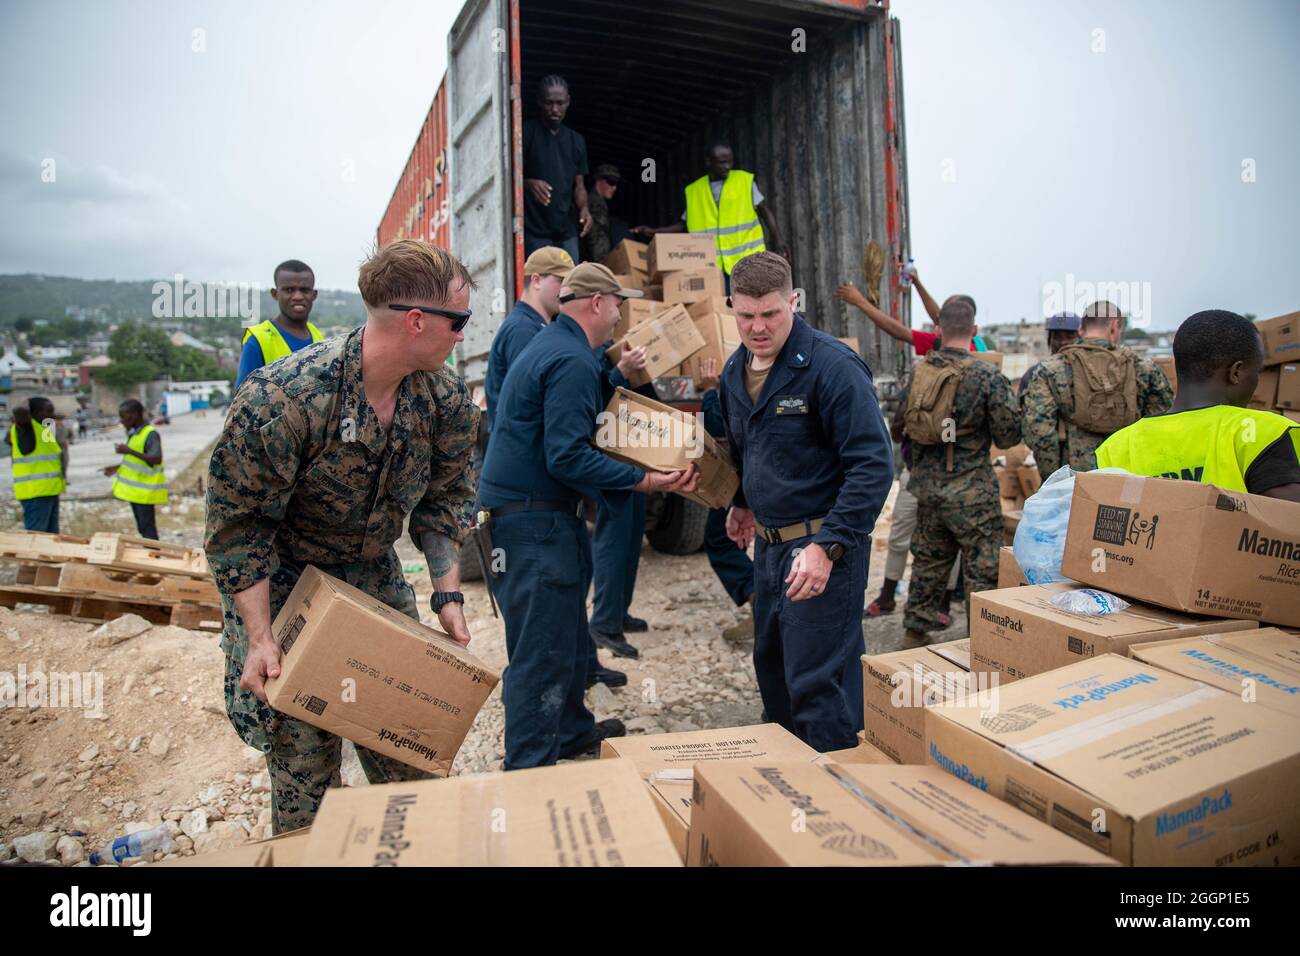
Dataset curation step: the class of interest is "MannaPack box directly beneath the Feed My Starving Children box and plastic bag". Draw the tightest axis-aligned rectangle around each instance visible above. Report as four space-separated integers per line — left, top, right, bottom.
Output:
970 581 1256 684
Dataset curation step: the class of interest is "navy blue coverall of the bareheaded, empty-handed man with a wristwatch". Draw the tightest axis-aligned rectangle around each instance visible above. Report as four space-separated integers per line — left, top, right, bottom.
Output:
719 315 893 752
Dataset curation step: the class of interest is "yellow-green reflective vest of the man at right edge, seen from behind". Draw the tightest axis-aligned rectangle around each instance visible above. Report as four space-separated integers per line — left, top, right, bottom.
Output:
1097 405 1300 492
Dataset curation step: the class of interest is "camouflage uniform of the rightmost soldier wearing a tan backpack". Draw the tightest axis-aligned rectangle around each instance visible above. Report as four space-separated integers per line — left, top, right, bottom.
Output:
1019 337 1174 481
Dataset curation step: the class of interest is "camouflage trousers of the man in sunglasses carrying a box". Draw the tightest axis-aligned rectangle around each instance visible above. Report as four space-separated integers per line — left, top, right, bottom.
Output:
221 549 430 834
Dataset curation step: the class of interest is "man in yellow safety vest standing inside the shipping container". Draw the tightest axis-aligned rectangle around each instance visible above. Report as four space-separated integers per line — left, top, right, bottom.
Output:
632 143 790 295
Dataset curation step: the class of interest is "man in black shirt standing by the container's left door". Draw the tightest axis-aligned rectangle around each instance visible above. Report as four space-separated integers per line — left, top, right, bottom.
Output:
524 75 592 263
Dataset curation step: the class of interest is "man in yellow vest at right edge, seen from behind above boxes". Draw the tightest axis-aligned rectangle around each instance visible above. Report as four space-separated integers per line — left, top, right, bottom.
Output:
1097 310 1300 502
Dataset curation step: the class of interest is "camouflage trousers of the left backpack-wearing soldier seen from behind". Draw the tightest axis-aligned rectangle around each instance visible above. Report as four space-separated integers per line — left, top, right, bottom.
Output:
902 494 1002 632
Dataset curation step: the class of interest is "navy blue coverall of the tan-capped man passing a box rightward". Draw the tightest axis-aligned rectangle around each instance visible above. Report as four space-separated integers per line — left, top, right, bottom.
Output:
478 313 645 770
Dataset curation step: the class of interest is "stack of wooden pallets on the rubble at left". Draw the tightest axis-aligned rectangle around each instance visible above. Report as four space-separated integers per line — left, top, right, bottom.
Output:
0 532 221 631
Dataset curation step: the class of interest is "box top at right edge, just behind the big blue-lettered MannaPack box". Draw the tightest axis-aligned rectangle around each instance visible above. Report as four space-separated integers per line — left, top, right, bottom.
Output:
1128 627 1300 726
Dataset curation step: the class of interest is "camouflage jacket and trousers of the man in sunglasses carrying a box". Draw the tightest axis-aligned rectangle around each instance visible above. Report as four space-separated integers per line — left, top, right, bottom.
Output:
205 329 478 832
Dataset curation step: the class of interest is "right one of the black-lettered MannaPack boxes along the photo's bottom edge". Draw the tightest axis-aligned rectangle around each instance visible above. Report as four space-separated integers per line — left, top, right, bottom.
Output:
688 763 1113 866
